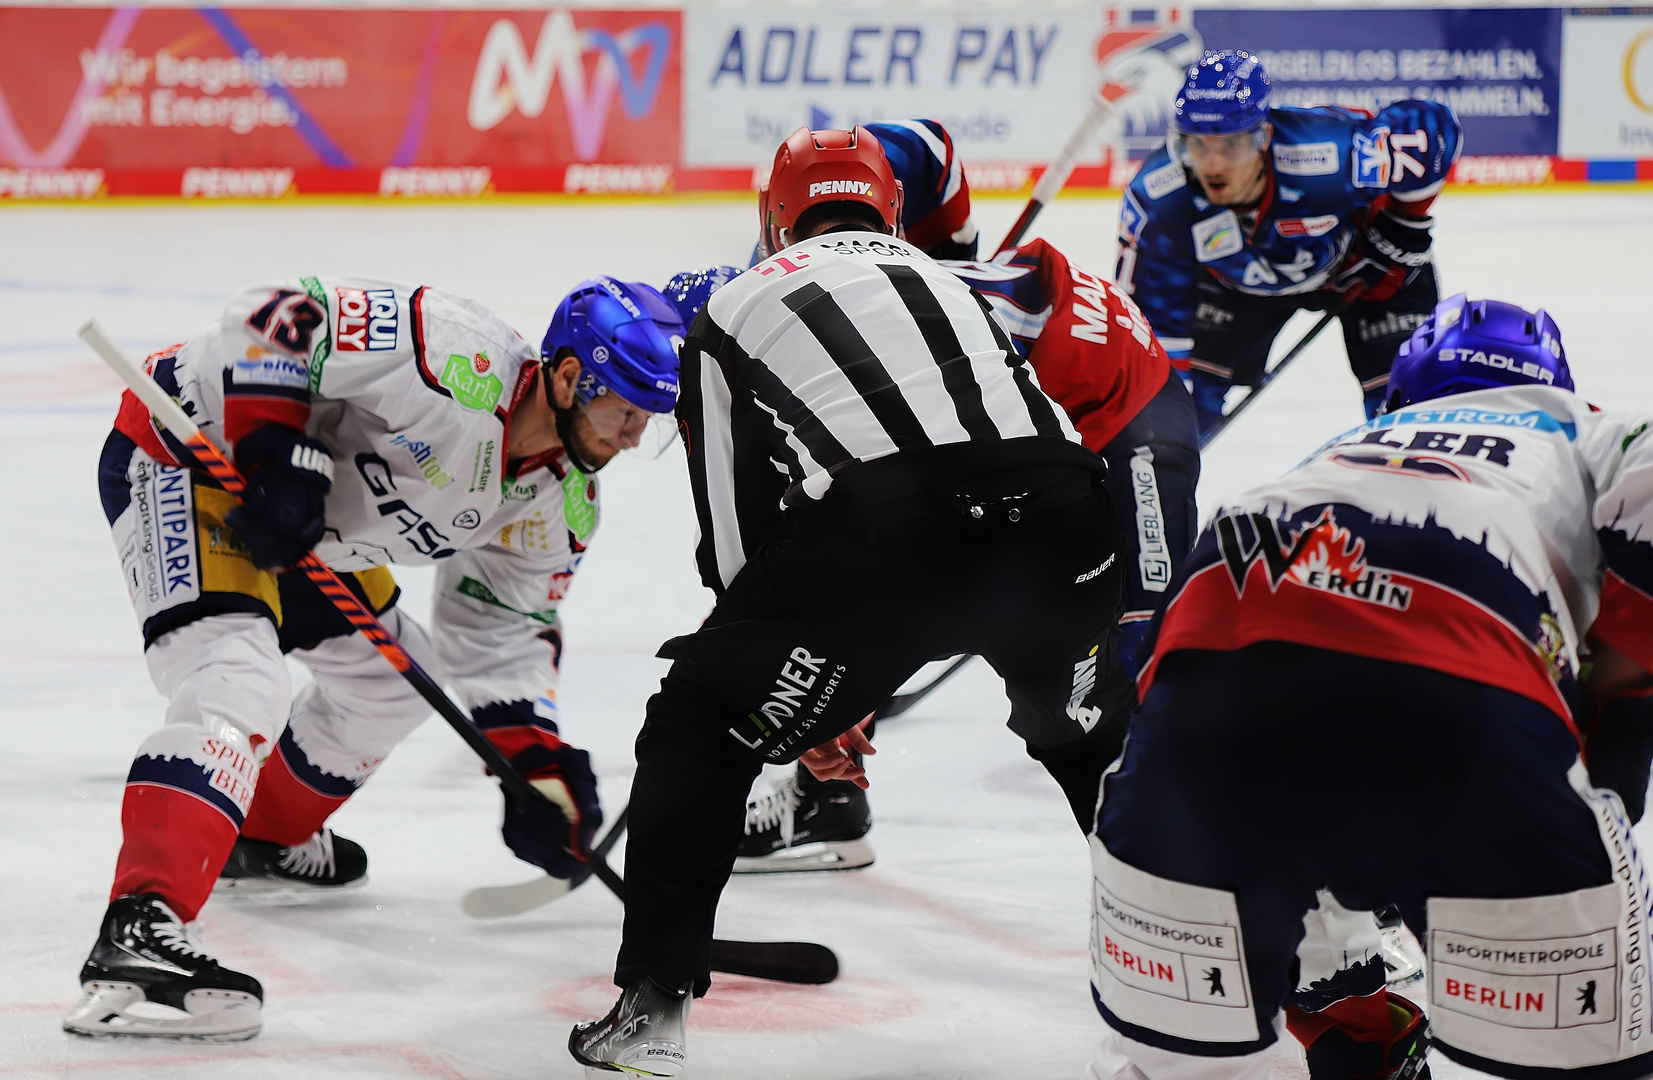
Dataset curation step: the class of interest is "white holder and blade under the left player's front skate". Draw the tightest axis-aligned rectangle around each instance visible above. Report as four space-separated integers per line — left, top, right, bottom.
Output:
63 982 264 1042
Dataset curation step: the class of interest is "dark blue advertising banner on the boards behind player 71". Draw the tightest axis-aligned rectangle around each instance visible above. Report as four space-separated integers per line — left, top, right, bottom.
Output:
1193 7 1562 155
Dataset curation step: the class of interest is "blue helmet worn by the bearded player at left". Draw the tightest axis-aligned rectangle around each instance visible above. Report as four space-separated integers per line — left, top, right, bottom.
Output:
539 278 683 412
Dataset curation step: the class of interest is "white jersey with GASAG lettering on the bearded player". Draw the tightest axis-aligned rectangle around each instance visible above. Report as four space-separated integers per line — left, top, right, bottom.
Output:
117 278 598 708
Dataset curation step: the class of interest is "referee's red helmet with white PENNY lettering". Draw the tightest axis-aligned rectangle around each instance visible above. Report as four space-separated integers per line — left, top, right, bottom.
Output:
757 124 901 255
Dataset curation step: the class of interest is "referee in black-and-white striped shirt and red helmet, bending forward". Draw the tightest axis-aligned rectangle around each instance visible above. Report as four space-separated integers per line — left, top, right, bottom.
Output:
569 127 1134 1077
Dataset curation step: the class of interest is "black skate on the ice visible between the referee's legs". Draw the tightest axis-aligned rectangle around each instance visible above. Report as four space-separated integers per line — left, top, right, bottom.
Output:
734 764 873 873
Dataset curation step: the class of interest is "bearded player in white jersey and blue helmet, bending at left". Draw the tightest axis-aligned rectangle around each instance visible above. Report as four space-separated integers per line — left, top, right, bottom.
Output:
63 278 683 1040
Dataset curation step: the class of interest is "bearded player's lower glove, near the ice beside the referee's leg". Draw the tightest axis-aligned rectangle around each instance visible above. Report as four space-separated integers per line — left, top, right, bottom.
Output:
471 701 603 878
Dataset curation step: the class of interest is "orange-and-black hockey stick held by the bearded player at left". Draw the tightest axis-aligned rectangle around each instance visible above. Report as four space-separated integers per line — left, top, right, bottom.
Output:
79 319 838 982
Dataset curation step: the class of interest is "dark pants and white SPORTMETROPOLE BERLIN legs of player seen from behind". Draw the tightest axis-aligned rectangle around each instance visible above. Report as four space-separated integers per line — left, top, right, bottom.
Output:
1088 642 1653 1080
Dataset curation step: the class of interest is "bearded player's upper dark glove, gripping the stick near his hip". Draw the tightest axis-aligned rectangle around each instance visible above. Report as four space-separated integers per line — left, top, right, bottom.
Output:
225 423 332 571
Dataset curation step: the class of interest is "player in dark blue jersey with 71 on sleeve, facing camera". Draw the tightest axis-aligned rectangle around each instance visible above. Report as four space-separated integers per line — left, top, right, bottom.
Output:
1114 51 1461 432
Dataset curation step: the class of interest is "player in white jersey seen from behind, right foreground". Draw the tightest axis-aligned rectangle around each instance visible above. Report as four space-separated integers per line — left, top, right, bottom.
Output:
1086 296 1653 1080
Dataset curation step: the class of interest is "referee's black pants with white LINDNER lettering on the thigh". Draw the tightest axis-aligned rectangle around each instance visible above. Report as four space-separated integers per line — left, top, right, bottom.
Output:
615 465 1136 994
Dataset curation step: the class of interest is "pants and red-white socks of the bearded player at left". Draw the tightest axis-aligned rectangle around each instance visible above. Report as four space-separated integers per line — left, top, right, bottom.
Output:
99 433 436 921
